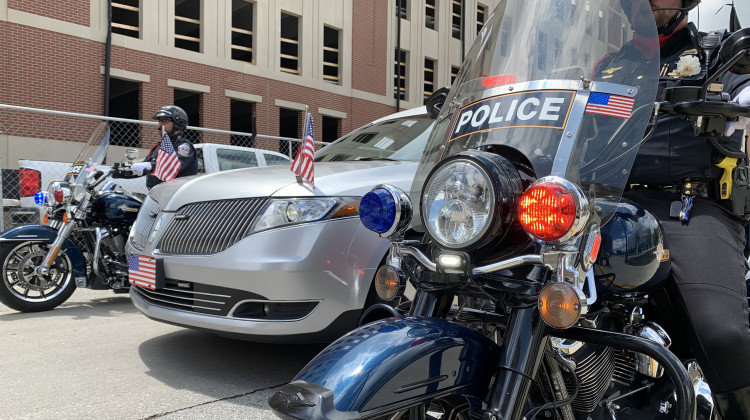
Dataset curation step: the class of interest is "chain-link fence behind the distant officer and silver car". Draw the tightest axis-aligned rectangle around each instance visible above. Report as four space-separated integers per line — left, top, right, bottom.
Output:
0 104 324 230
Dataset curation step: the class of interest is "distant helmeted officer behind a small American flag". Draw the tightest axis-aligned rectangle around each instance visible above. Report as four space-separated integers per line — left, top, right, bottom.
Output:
130 105 198 189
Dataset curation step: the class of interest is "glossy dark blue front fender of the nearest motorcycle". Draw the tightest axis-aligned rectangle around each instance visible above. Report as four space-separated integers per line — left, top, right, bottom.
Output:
269 317 500 419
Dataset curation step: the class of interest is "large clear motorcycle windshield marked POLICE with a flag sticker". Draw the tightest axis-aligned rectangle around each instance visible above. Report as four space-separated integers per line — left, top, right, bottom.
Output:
411 0 659 230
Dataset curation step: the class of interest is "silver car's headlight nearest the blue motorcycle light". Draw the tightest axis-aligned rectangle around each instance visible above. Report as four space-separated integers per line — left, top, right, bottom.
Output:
251 197 359 232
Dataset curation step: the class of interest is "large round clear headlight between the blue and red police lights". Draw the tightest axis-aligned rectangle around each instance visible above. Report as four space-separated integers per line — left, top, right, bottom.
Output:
422 159 496 248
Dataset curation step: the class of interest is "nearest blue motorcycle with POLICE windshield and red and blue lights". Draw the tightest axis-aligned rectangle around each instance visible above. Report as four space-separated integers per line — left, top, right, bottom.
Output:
269 0 750 420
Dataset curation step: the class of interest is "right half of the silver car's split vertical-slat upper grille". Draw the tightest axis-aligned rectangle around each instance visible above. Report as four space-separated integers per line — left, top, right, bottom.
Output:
158 198 268 255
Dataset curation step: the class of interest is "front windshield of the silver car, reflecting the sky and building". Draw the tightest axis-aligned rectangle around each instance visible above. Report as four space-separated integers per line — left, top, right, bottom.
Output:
315 115 435 162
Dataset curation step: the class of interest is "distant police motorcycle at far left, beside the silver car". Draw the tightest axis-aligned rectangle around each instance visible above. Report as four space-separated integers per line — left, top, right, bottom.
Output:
0 122 142 312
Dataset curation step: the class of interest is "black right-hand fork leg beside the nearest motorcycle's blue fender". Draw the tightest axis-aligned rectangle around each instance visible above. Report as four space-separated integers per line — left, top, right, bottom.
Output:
484 307 549 420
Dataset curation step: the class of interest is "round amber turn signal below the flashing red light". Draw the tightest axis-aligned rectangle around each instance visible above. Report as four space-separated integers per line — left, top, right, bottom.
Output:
539 282 586 330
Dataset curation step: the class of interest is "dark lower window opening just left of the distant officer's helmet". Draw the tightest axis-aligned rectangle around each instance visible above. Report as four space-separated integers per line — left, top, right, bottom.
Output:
109 78 141 147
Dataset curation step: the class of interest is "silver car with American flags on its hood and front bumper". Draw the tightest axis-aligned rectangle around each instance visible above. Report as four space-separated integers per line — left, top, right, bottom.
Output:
128 107 433 343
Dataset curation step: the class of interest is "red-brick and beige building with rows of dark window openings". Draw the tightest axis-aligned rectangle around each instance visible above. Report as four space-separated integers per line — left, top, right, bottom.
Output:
0 0 506 151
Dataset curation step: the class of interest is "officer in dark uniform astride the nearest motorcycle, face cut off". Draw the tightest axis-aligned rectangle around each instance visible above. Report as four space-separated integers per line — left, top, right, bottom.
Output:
604 0 750 420
